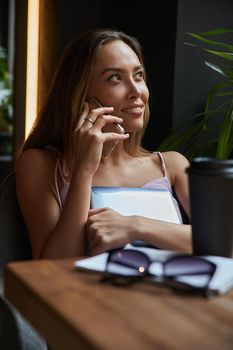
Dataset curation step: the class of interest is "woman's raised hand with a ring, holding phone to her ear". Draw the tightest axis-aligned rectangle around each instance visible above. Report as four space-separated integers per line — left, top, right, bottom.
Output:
73 103 129 175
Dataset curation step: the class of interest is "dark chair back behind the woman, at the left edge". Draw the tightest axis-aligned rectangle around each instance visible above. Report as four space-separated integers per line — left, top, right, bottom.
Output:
0 172 32 264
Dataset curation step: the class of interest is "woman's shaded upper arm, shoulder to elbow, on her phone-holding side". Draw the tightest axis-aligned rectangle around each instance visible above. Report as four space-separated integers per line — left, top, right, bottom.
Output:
16 149 60 257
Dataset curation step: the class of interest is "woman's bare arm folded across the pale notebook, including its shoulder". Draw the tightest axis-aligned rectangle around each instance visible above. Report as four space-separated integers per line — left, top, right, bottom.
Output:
87 152 192 255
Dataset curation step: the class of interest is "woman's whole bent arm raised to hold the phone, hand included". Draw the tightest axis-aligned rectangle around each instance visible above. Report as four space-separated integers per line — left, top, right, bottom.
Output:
16 104 128 258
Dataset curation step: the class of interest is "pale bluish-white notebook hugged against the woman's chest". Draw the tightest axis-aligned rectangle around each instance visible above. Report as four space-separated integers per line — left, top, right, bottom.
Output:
91 186 181 223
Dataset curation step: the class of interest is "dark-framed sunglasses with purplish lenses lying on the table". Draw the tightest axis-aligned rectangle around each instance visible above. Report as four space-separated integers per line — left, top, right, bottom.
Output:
104 249 216 296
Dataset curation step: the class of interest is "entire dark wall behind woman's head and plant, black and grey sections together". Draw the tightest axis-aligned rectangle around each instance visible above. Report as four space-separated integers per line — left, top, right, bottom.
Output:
57 0 233 150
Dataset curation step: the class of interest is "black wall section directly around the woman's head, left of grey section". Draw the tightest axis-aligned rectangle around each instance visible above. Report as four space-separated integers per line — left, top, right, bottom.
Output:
58 0 177 150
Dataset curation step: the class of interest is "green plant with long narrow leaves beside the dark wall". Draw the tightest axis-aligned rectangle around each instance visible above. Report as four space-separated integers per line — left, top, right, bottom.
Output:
159 28 233 159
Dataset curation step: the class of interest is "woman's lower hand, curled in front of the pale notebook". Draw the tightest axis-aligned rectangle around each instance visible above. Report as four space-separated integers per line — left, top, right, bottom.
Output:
87 208 136 255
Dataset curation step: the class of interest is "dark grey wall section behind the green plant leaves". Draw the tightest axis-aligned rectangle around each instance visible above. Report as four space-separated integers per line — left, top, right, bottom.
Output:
173 0 233 126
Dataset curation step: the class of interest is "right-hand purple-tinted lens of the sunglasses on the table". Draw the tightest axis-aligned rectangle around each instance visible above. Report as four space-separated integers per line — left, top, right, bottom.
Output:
164 256 215 277
